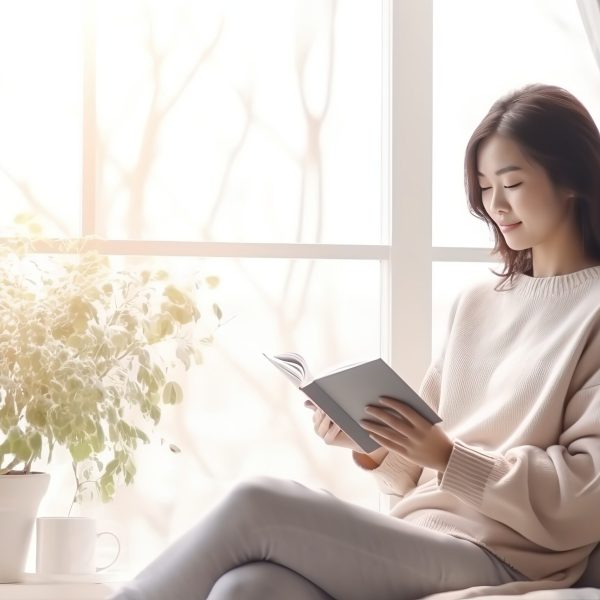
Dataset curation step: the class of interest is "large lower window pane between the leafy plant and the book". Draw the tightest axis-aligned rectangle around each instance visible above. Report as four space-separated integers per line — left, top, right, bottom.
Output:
32 259 380 572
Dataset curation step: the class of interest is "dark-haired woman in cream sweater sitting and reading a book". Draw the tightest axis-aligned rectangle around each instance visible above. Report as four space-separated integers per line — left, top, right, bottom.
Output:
111 85 600 600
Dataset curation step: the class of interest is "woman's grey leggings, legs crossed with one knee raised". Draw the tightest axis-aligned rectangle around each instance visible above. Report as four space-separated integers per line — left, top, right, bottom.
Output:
114 477 526 600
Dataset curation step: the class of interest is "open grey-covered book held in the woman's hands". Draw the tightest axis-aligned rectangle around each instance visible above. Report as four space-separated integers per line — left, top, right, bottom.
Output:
264 352 441 452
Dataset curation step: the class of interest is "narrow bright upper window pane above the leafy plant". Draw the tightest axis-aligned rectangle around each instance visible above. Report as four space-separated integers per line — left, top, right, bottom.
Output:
0 0 82 237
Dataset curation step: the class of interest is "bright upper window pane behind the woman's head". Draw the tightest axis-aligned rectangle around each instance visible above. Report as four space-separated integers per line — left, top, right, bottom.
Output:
433 0 600 247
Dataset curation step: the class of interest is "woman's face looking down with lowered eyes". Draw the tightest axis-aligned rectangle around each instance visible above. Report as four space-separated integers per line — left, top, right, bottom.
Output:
477 134 579 262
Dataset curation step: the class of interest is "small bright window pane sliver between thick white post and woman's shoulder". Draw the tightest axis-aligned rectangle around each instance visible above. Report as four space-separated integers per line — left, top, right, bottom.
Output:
431 262 503 360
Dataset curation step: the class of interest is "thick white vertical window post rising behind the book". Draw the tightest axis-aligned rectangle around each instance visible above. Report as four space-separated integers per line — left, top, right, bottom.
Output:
386 0 433 389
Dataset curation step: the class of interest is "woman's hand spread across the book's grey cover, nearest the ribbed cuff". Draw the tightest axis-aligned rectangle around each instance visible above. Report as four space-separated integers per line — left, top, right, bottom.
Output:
360 397 453 472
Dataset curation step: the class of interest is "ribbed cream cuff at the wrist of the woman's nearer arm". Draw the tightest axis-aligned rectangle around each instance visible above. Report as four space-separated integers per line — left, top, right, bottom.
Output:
438 440 496 507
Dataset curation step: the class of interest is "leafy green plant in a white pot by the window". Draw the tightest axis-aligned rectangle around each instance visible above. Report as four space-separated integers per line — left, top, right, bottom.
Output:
0 225 221 582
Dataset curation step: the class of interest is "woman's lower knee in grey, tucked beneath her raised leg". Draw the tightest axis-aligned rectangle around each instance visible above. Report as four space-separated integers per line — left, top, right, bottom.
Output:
207 561 332 600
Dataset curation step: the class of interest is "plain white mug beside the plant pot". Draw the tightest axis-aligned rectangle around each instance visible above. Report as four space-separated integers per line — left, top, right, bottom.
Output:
36 517 121 575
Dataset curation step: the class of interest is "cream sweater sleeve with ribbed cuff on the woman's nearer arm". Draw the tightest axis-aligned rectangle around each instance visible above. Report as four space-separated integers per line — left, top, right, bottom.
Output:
438 385 600 552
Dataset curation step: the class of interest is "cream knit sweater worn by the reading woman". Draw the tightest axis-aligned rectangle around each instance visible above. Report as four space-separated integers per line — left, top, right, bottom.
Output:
364 267 600 599
